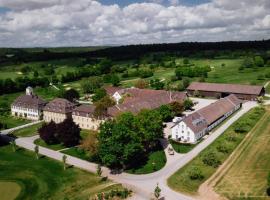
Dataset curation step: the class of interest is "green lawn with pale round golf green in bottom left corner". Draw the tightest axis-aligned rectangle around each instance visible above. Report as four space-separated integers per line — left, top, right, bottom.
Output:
0 145 122 200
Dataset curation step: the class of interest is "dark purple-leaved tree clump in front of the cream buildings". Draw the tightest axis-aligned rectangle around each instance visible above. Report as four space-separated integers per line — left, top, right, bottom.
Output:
38 118 81 147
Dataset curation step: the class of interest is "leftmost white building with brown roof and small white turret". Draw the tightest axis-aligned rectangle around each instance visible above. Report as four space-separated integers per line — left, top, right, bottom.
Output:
11 87 46 120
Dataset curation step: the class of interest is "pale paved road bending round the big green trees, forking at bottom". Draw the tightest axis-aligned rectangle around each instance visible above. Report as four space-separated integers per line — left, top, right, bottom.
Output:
5 102 257 200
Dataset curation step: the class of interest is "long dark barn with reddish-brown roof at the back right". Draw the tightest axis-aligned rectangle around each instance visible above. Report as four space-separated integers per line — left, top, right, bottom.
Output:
187 82 265 101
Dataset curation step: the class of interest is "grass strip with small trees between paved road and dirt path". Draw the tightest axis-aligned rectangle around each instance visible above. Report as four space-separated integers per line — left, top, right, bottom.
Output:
167 108 265 194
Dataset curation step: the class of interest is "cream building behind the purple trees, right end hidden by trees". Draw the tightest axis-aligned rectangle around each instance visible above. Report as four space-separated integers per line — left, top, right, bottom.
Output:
72 105 104 130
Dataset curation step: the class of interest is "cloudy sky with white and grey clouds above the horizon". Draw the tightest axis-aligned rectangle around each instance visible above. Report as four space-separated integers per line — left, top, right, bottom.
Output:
0 0 270 47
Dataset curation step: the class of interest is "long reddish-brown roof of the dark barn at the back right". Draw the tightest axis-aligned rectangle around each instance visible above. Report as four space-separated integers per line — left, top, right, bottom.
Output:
187 82 263 95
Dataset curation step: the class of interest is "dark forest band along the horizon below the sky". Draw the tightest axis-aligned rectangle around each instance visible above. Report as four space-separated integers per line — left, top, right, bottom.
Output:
0 40 270 65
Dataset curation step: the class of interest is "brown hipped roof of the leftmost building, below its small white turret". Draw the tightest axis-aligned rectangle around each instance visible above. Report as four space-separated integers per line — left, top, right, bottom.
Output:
12 95 46 109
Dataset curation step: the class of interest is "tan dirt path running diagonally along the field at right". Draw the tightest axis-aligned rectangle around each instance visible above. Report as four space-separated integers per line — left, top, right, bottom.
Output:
196 108 269 200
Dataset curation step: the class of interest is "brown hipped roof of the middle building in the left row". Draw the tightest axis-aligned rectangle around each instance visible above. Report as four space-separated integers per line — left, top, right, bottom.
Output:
44 98 75 114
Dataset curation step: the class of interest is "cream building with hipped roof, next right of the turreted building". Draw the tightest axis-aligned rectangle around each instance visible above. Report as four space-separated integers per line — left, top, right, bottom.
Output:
43 98 75 124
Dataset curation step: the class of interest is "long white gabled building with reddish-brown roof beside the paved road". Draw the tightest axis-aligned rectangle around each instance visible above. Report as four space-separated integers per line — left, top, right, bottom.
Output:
171 95 242 143
